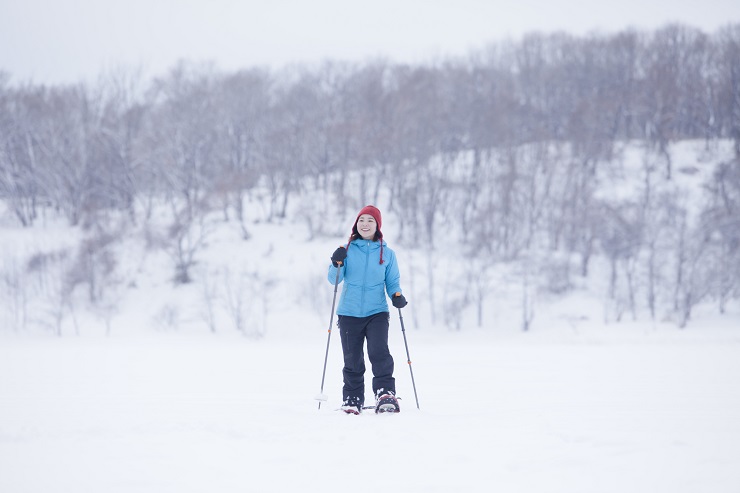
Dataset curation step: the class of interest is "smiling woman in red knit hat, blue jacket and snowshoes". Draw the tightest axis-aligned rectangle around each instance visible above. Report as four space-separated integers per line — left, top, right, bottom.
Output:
328 205 406 414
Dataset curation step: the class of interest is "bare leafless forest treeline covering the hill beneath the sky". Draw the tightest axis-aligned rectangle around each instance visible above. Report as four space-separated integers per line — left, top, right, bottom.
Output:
0 24 740 327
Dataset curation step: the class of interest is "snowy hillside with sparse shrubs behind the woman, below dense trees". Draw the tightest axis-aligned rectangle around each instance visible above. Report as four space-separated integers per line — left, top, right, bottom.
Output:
0 141 738 338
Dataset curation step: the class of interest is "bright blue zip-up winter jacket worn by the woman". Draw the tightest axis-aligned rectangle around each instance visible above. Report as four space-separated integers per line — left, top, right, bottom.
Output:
328 238 402 317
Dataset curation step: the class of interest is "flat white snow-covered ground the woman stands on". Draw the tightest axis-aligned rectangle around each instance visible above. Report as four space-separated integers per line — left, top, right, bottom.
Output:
0 319 740 493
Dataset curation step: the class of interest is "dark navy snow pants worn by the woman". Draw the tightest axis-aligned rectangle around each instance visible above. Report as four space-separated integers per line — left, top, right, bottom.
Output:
338 312 396 404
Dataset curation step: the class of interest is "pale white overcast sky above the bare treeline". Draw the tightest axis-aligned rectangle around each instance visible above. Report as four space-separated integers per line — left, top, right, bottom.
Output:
0 0 740 83
